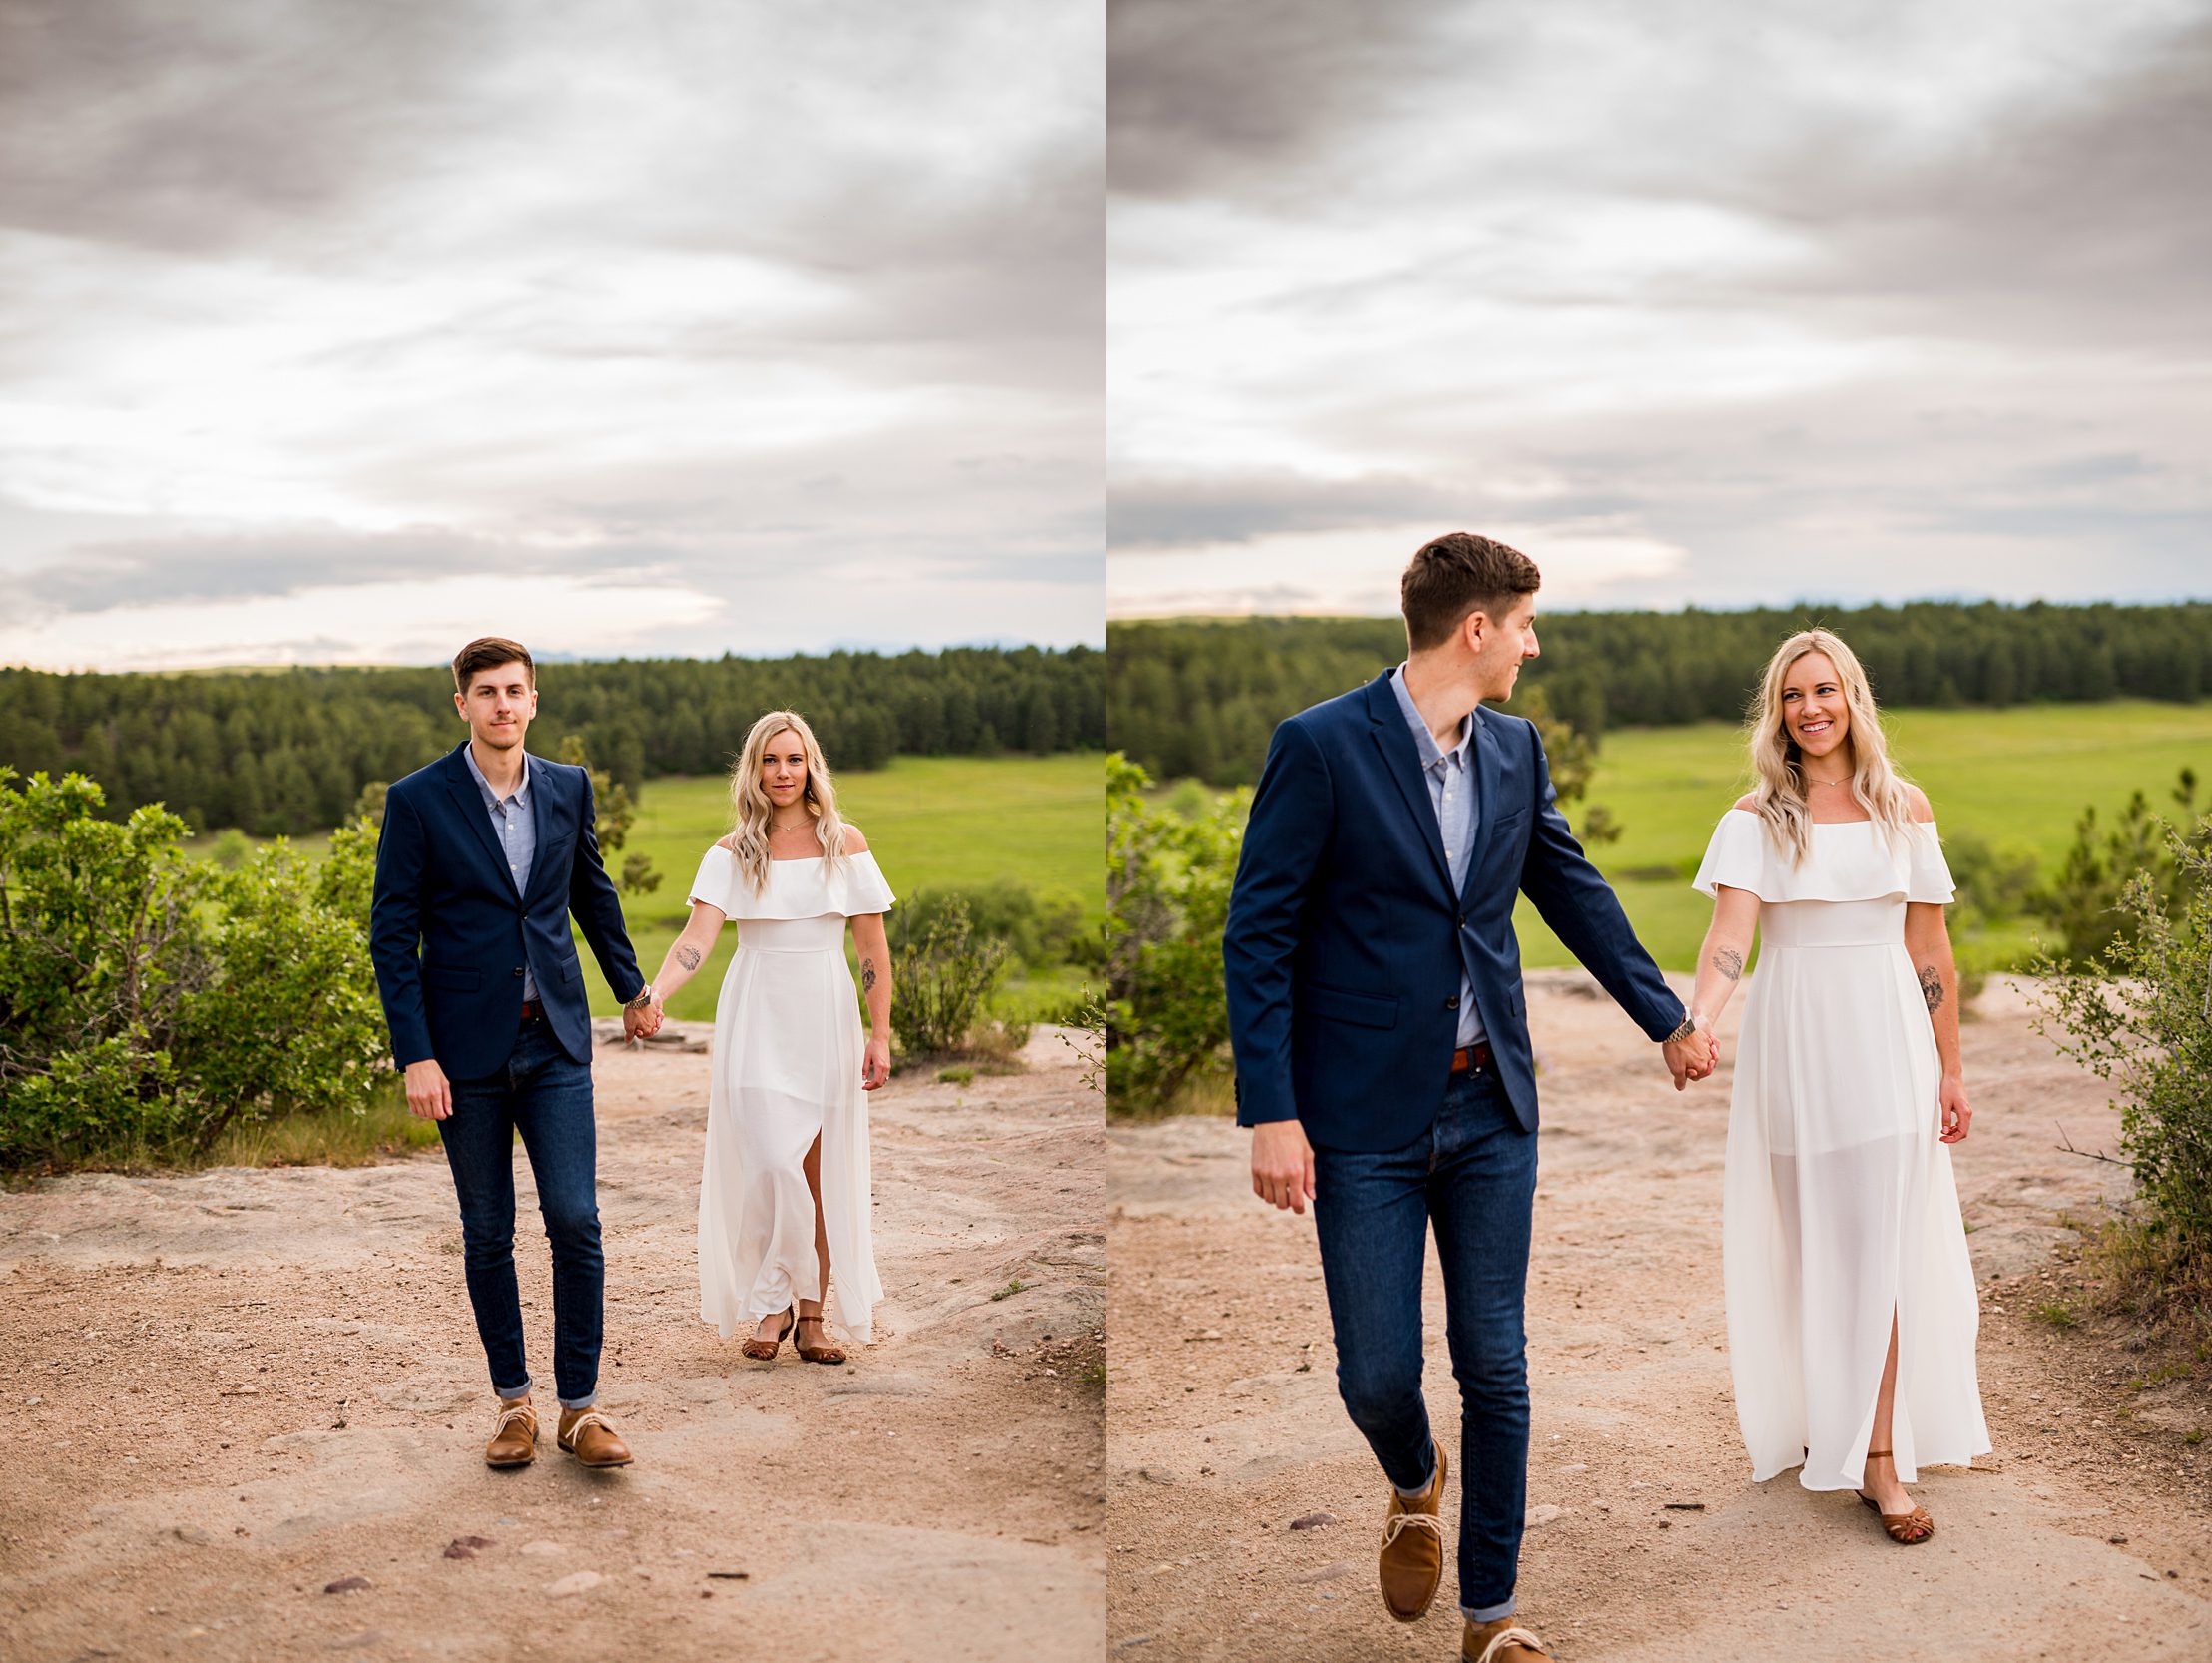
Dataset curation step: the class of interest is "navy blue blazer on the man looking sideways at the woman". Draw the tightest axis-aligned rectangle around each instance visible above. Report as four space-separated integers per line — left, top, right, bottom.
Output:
1221 672 1683 1150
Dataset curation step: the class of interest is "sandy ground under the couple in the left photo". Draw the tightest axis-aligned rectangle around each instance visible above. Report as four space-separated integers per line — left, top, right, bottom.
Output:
0 1024 1106 1663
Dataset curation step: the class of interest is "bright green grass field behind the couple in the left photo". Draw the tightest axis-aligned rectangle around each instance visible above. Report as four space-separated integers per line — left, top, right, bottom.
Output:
186 752 1106 1022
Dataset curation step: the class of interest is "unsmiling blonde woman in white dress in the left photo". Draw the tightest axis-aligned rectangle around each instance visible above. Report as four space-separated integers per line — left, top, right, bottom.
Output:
648 710 893 1363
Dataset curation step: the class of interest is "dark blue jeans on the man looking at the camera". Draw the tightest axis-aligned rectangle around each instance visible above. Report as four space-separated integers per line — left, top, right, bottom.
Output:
438 1019 606 1408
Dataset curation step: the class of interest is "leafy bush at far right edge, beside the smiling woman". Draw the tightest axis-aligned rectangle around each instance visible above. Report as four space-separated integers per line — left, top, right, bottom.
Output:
2037 821 2212 1287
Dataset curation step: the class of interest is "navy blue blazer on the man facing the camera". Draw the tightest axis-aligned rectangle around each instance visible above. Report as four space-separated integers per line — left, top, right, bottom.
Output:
369 741 646 1079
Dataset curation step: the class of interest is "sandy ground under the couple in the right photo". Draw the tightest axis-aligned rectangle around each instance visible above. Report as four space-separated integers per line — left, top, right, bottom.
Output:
1106 971 2212 1663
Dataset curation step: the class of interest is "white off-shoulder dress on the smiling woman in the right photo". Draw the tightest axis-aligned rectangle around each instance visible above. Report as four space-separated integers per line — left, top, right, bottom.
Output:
1697 810 1988 1490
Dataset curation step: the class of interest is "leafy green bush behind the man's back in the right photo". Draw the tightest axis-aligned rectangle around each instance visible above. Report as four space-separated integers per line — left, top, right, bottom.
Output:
1106 752 1252 1115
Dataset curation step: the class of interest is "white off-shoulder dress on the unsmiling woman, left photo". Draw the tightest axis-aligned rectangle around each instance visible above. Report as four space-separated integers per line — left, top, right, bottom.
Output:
690 844 893 1343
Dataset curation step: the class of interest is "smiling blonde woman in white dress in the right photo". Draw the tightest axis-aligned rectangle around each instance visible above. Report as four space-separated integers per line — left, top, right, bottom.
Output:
1690 630 1988 1543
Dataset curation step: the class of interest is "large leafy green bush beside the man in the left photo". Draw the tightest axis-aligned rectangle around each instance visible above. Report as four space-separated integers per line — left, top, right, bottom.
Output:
0 768 385 1168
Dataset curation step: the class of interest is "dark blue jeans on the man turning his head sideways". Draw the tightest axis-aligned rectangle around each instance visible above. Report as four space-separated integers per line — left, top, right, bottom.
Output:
1314 1070 1535 1623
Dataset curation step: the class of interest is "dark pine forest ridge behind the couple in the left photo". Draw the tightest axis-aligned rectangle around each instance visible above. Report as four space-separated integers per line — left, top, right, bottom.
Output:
0 646 1106 835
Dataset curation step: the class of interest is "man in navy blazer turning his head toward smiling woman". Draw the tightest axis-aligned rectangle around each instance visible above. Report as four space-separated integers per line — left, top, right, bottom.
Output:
1221 533 1714 1663
